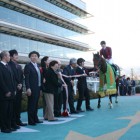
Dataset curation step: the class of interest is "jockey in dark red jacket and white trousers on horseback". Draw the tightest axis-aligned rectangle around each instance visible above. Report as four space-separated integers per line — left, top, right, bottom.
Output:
100 41 118 76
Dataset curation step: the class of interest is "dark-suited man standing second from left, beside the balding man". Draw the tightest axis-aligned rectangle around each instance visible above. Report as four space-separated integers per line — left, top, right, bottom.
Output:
9 50 27 126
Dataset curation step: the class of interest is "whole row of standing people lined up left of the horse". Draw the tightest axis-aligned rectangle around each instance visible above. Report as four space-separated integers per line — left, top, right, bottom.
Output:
0 50 95 133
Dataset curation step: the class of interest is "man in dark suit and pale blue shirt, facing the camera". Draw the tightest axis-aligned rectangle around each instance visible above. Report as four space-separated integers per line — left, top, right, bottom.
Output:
24 51 42 125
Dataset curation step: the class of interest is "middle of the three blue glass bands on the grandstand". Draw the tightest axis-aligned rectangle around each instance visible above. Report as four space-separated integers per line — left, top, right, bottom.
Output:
0 7 86 43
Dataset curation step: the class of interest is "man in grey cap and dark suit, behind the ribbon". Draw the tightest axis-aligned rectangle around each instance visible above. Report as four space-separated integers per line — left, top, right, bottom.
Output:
63 58 78 114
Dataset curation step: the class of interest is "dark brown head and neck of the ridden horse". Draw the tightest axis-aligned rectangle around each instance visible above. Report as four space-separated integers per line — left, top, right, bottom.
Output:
93 53 107 73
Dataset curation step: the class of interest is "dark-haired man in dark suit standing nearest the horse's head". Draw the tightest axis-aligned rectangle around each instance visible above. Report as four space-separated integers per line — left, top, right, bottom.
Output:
76 58 93 112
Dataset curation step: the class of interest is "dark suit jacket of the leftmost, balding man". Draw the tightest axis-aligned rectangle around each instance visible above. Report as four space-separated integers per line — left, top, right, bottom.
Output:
0 62 16 100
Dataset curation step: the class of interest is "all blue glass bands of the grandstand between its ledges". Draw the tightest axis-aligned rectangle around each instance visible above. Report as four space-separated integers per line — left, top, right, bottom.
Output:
0 0 92 63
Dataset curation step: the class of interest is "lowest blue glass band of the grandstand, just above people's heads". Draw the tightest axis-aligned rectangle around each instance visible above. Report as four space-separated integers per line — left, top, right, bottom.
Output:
0 34 82 59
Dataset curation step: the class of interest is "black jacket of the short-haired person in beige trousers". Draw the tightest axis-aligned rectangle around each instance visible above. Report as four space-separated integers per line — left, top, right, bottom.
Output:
45 68 62 94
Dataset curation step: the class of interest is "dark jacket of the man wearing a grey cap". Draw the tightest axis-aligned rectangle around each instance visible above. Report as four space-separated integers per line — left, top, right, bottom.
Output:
62 65 76 86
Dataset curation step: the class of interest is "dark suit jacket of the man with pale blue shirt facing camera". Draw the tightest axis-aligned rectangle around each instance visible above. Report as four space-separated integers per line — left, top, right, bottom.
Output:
24 62 41 93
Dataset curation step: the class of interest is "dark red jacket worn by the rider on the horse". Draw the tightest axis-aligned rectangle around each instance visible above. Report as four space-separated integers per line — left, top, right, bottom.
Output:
100 47 112 59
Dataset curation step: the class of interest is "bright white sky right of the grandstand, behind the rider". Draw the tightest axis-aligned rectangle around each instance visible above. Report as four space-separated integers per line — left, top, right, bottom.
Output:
82 0 140 76
